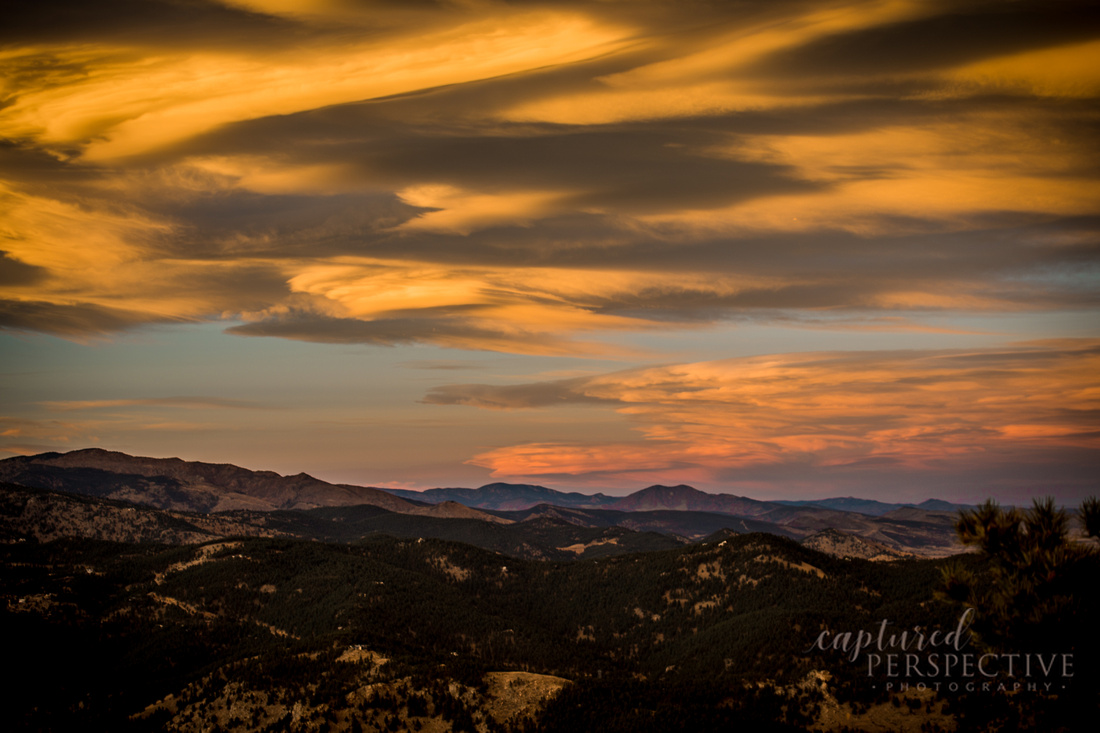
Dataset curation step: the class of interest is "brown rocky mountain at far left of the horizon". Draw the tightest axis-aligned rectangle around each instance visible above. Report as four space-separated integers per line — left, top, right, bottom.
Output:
0 448 417 512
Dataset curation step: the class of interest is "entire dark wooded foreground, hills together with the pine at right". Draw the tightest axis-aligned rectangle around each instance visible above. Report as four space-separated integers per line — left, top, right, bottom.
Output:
0 485 1100 733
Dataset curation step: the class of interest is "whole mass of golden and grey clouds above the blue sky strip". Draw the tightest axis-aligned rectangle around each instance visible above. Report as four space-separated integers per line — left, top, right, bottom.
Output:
0 0 1100 355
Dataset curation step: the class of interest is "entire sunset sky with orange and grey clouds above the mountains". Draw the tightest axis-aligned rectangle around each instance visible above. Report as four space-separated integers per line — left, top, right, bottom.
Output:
0 0 1100 503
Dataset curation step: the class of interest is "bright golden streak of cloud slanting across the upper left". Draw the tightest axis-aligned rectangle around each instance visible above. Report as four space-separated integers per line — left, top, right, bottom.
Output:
0 12 624 161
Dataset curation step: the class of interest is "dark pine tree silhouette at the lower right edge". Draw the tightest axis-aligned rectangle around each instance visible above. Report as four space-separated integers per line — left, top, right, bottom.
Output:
941 497 1100 731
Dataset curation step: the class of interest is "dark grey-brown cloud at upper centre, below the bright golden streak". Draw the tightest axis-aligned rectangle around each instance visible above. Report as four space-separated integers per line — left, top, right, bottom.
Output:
162 113 821 214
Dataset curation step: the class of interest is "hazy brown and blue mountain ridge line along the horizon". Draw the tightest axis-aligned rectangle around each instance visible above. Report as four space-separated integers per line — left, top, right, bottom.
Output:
0 448 961 556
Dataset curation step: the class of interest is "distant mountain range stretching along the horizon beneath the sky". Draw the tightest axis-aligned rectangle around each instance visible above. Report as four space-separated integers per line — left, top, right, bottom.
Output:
0 449 961 559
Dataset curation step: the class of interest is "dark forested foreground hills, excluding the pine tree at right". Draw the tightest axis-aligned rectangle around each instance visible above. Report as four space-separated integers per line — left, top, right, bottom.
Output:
2 535 976 730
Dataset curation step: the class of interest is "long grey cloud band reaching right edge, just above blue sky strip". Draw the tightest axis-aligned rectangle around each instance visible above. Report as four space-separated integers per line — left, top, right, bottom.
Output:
398 218 1100 310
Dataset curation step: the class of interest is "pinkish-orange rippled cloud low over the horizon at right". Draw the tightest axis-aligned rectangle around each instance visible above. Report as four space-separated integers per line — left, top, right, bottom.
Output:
425 340 1100 488
